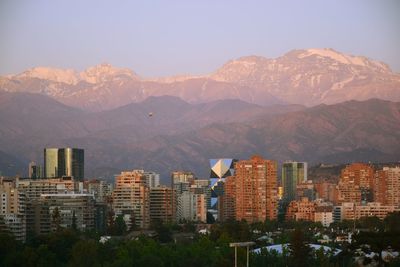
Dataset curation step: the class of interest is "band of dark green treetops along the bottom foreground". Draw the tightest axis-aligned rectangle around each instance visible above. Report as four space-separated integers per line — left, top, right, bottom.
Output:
0 218 400 267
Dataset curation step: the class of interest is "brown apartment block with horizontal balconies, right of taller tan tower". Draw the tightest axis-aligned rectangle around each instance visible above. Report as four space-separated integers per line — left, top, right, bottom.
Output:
150 186 176 223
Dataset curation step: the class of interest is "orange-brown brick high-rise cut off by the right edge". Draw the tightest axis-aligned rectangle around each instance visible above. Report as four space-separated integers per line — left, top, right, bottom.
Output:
373 167 400 206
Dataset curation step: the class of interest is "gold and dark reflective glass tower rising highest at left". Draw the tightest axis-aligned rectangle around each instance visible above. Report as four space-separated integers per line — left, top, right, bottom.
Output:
44 148 85 181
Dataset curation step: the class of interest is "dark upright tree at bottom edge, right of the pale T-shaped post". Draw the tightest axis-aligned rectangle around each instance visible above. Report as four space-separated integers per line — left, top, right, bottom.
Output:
289 228 311 267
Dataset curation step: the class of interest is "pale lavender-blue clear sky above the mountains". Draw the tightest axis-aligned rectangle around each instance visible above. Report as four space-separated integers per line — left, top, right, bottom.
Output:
0 0 400 77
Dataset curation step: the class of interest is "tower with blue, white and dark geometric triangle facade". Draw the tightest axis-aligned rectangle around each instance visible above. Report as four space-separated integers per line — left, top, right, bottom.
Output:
210 159 237 210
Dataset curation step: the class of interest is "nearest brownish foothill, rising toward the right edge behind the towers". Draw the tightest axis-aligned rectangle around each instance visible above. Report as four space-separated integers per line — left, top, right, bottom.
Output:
83 99 400 181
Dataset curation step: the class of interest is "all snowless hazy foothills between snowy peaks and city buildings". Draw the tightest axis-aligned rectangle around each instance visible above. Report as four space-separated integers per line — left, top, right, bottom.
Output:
0 93 400 182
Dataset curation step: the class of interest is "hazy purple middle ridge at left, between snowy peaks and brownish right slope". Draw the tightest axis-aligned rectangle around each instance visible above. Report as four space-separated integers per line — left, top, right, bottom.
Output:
0 93 303 176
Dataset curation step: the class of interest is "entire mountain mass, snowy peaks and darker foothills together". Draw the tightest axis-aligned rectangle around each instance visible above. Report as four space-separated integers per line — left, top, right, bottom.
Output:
0 49 400 182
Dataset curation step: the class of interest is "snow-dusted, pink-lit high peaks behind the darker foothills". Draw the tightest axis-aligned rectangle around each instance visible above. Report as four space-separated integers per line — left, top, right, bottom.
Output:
0 49 400 111
